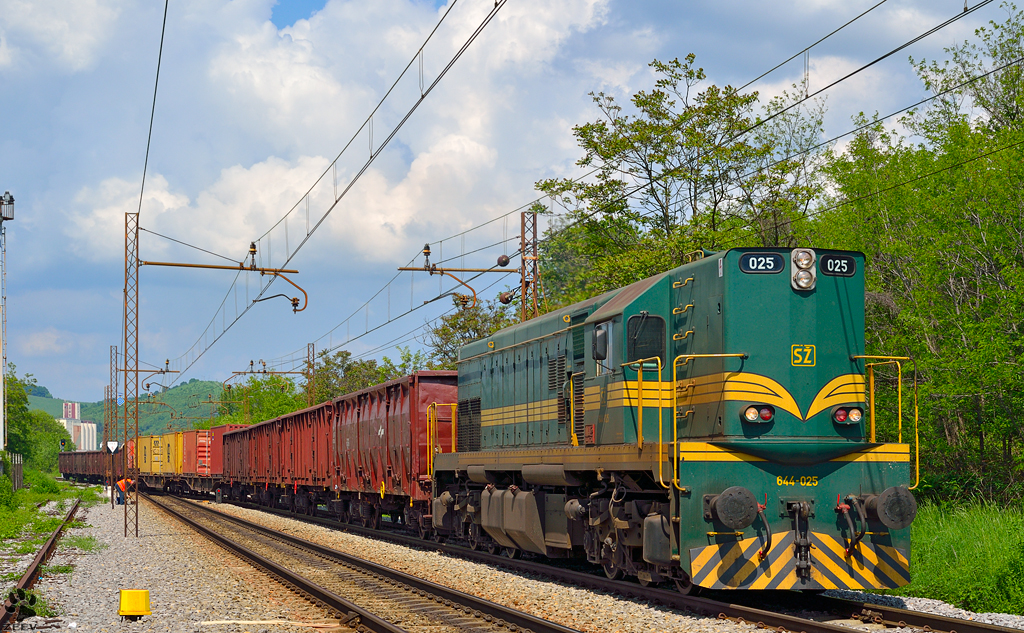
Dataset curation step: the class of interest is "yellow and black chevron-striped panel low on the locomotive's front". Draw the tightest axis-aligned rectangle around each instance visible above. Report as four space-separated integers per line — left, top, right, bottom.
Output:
690 531 910 589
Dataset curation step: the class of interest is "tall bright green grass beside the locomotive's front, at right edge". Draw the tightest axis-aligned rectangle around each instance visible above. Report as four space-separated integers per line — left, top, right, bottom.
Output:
889 503 1024 615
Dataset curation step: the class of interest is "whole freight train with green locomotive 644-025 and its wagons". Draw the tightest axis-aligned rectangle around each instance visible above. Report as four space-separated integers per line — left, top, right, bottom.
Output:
59 248 916 592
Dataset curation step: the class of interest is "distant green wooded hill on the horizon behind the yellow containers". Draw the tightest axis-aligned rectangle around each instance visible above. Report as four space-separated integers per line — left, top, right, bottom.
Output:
29 379 221 437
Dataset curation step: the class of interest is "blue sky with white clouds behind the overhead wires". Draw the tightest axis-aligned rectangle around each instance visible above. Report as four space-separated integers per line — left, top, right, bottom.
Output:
0 0 1005 400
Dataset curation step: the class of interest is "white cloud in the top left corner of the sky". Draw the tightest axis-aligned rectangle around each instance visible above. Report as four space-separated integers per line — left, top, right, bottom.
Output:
0 0 125 71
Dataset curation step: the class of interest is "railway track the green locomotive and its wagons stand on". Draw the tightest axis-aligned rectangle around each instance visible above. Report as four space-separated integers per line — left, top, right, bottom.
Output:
209 493 1020 633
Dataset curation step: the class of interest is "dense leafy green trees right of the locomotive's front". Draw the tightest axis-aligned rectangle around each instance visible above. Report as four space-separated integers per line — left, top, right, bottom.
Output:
814 86 1024 499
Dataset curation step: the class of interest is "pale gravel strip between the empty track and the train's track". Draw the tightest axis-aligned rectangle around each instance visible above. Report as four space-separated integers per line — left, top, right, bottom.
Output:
202 502 756 633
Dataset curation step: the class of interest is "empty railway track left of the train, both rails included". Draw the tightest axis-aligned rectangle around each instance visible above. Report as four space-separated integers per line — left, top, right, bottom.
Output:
146 496 589 633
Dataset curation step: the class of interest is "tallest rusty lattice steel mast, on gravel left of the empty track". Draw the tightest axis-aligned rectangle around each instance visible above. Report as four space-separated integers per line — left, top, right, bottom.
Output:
123 213 139 537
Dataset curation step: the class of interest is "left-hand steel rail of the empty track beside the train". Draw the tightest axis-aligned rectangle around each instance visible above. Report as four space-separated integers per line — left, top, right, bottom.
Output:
142 495 408 633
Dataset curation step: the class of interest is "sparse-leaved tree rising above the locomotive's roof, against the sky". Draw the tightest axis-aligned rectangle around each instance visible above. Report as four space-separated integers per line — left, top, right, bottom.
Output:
537 54 823 304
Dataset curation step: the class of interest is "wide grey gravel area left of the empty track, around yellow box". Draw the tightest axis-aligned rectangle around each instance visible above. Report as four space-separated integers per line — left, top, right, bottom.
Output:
28 495 337 633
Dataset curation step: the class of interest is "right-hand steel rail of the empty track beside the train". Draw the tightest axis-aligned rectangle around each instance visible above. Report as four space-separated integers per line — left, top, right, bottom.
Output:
167 495 585 633
